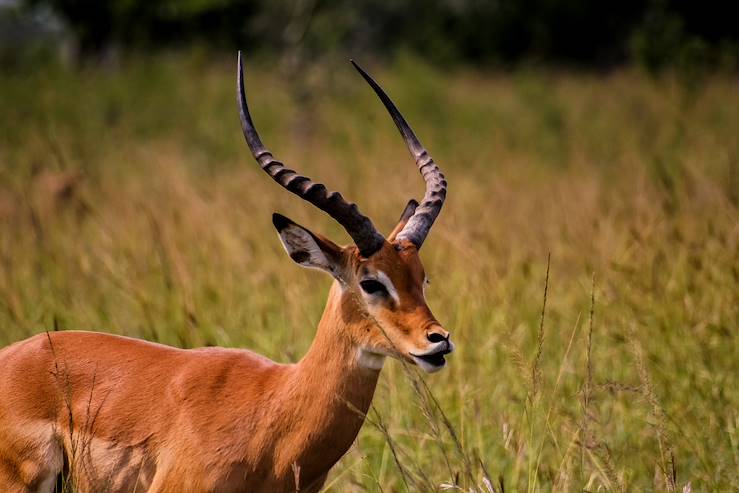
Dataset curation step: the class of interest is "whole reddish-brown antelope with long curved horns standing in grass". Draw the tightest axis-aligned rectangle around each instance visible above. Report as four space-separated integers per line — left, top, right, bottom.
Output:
0 52 454 493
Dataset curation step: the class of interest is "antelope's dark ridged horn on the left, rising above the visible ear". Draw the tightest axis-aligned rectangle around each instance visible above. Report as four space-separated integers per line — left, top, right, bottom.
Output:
236 51 385 257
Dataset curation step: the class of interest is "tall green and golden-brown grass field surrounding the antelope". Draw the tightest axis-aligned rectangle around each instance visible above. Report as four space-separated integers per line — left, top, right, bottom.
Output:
0 55 739 492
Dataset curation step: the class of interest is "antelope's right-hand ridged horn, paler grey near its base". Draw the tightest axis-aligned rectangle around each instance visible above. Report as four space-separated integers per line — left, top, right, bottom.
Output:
351 60 447 249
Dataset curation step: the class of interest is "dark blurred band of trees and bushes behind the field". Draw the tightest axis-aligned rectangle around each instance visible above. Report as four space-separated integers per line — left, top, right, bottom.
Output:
1 0 739 70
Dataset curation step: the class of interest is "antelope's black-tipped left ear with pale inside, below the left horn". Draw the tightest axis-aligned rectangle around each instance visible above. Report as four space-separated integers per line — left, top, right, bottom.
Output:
272 213 343 280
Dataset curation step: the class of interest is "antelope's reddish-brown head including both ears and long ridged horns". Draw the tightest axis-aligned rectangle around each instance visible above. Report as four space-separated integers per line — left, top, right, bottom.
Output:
237 52 454 372
